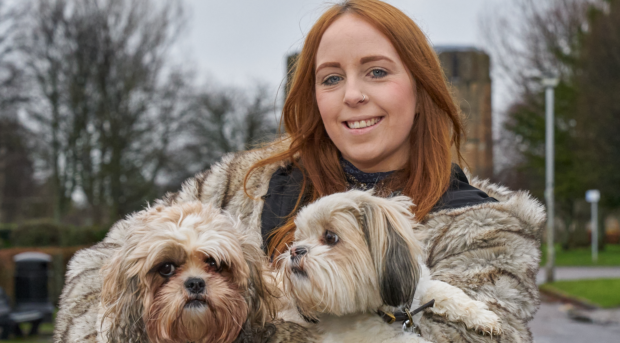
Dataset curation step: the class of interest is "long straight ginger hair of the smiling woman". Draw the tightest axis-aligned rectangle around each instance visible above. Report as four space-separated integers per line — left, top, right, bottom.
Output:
244 0 464 255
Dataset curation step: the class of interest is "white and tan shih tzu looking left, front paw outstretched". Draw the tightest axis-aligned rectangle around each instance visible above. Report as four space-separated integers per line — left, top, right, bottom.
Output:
279 190 501 343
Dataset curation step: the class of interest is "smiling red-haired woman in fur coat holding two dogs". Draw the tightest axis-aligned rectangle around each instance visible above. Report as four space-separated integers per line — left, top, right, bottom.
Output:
56 0 544 342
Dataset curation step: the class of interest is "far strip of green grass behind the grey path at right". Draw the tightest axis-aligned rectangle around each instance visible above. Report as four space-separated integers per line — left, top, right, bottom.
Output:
540 244 620 267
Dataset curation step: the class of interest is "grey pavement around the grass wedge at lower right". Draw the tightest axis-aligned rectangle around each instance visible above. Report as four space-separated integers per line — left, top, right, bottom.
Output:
530 267 620 343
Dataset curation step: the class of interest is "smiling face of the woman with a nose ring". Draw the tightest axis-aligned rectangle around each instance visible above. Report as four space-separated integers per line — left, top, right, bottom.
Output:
315 14 416 172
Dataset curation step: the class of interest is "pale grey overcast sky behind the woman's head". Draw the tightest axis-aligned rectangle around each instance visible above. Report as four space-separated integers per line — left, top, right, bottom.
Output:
175 0 506 104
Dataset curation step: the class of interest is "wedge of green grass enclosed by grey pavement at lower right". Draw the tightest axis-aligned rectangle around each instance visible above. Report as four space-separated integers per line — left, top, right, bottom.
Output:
540 279 620 308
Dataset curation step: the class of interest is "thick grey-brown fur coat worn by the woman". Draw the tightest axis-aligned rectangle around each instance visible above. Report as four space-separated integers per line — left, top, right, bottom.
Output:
54 140 545 343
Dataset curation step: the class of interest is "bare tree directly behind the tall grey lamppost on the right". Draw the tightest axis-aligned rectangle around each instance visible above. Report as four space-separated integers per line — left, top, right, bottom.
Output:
481 0 604 247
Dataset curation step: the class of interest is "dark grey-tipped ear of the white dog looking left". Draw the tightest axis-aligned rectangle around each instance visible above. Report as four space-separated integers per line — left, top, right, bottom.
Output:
360 193 423 306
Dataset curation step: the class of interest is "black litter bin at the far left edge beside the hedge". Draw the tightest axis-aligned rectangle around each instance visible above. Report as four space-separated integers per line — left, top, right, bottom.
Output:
13 252 54 322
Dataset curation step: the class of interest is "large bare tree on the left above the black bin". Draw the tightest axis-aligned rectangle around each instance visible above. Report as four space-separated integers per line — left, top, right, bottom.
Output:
20 0 185 222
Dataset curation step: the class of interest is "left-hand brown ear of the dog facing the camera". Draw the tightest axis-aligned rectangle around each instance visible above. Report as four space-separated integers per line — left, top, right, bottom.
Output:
100 247 148 342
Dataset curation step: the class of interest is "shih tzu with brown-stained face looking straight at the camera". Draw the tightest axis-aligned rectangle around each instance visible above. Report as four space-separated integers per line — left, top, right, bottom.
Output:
97 202 277 343
